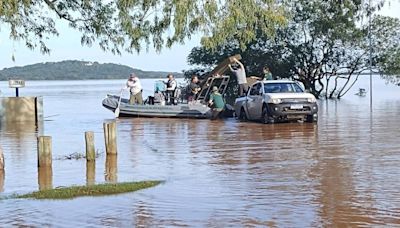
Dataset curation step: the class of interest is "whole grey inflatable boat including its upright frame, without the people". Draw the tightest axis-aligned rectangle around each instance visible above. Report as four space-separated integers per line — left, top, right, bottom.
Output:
102 55 241 119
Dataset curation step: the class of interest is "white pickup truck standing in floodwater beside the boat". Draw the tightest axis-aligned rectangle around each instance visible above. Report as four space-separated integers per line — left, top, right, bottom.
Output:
235 80 318 123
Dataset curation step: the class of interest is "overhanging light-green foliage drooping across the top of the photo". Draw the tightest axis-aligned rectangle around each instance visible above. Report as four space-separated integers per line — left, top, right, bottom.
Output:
0 0 286 53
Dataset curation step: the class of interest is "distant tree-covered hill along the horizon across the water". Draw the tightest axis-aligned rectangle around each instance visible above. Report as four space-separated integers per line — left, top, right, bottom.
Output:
0 60 183 81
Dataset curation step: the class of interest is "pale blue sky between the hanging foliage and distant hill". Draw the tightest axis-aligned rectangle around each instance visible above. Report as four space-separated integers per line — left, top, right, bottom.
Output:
0 0 400 72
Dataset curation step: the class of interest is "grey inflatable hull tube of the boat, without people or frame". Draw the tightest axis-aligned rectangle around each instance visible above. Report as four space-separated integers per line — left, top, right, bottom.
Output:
102 95 210 119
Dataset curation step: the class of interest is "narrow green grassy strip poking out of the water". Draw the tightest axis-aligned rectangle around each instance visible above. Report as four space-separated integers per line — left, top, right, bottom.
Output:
16 181 161 199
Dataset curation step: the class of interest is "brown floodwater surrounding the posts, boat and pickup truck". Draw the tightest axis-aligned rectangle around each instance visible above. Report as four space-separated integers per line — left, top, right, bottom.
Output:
0 77 400 227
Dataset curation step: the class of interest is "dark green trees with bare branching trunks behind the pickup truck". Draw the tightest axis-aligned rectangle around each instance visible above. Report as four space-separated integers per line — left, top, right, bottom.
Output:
188 0 400 98
